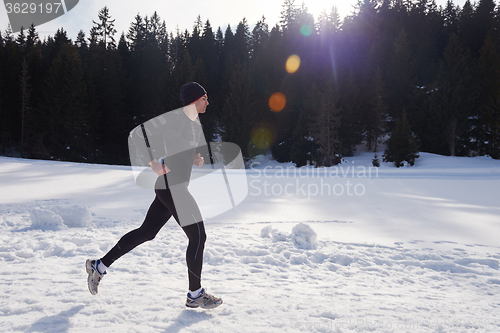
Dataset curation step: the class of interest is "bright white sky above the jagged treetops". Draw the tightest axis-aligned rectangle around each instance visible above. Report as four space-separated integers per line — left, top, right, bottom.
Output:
0 0 475 40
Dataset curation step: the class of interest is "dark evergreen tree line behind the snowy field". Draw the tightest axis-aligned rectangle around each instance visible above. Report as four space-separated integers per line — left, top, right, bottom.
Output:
0 0 500 166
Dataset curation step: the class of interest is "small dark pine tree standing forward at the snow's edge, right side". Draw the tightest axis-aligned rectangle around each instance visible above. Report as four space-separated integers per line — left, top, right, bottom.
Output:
383 111 419 168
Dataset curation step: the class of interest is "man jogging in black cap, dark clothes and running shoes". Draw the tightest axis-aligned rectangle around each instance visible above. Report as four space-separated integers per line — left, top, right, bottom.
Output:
86 82 222 309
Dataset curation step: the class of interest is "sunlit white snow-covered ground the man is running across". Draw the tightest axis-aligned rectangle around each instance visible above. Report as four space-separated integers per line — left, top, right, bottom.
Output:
0 153 500 332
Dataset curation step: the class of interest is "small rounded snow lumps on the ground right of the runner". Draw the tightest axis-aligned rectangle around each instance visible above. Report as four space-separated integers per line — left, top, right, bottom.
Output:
260 222 317 250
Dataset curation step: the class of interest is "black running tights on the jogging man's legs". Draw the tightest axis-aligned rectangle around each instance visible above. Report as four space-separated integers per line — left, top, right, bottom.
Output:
101 184 206 291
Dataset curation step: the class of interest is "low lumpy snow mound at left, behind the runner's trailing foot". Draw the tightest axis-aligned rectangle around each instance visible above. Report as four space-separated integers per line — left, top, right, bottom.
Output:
31 205 92 230
